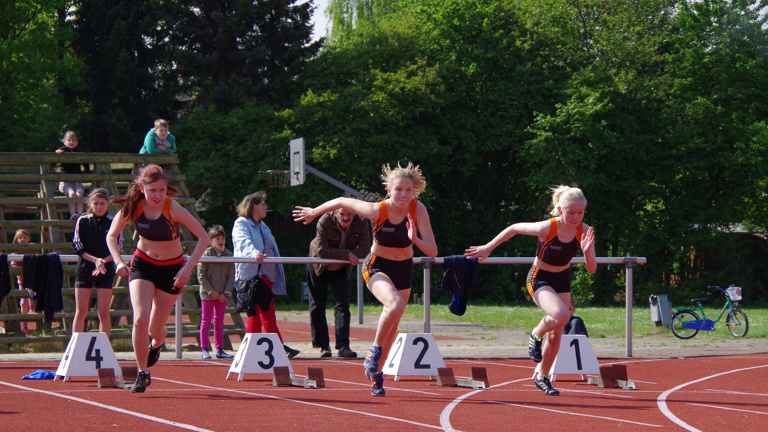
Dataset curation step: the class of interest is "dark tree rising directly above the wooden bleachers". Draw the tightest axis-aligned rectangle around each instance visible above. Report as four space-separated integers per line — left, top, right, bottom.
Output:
68 0 180 153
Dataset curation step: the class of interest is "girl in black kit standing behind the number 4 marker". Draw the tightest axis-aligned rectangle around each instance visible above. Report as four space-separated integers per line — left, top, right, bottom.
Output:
72 188 123 337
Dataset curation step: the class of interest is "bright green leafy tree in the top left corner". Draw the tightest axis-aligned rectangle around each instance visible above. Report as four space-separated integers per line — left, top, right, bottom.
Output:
0 0 83 151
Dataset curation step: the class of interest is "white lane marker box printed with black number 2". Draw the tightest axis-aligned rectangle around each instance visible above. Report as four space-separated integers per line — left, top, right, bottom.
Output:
382 333 445 381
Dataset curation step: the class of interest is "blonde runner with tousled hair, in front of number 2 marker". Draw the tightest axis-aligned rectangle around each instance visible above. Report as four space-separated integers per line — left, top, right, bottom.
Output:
293 163 437 396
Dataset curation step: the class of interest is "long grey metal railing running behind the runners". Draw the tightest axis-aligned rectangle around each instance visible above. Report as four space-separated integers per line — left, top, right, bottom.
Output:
8 254 647 359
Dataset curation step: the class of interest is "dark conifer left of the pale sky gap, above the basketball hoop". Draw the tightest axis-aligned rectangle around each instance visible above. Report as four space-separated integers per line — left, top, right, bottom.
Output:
171 0 321 111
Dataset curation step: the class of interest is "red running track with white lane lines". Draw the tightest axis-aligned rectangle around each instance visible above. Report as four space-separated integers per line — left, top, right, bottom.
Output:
0 354 768 432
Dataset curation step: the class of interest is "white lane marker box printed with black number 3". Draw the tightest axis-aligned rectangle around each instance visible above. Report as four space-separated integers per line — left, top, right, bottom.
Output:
227 333 294 381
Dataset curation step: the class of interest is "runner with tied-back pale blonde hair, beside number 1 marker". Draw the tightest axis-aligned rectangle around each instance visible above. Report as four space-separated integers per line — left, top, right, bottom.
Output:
465 186 597 395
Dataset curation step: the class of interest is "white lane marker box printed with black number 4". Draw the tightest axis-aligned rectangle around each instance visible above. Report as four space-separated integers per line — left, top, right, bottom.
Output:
53 333 122 382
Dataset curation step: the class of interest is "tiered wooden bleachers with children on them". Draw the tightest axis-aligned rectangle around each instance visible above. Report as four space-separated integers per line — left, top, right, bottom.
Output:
0 152 245 349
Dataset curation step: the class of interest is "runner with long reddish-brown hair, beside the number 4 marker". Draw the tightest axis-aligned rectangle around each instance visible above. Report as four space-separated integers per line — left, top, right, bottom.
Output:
107 165 208 393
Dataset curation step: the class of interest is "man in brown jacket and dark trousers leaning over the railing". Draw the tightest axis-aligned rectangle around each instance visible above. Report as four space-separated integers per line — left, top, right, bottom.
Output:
307 209 371 358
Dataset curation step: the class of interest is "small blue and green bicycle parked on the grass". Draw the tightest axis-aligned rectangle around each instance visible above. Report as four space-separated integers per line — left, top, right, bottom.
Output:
669 285 749 339
